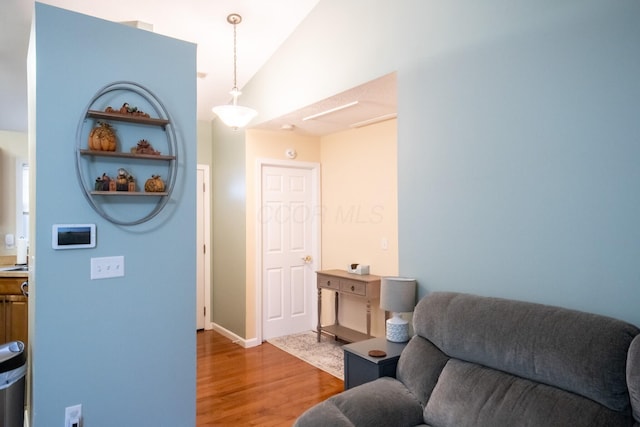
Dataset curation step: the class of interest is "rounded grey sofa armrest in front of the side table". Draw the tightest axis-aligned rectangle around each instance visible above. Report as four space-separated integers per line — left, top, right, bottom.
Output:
294 377 423 427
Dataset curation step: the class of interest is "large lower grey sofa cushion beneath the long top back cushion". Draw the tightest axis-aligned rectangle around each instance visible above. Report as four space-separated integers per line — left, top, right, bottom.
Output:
424 359 633 427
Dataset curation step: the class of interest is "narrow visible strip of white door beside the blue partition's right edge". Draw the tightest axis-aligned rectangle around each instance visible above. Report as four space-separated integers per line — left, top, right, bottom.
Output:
196 165 211 330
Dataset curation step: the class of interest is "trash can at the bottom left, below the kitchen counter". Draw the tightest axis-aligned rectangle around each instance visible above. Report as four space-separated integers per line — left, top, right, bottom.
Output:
0 341 27 427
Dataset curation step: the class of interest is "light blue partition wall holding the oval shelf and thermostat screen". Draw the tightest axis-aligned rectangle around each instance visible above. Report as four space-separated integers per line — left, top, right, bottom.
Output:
30 3 196 427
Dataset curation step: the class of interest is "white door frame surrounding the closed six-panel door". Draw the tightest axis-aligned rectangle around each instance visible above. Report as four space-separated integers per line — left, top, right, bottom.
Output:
255 159 322 345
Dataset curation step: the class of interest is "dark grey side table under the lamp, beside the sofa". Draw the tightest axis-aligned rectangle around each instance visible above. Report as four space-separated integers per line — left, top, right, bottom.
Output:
342 338 407 390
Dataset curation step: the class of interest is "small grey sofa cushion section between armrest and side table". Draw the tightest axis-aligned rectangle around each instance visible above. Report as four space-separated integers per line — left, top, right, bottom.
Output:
396 335 449 406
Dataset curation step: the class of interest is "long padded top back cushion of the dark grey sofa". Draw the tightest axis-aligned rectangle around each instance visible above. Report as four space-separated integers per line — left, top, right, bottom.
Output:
413 292 640 411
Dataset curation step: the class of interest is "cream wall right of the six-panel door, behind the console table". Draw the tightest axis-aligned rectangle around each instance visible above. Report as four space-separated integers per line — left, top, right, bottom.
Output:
321 120 398 336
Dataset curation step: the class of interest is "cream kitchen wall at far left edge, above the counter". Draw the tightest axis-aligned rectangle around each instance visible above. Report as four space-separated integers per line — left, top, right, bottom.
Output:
0 130 29 256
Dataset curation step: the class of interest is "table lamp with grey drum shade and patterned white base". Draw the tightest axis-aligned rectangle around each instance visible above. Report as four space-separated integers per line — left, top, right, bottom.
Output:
380 277 416 342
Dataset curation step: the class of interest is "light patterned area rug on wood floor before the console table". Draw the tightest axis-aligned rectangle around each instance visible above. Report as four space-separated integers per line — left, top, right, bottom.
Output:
267 331 344 380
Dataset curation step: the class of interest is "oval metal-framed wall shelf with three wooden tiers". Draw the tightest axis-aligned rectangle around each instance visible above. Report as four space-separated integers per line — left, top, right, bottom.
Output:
76 81 178 225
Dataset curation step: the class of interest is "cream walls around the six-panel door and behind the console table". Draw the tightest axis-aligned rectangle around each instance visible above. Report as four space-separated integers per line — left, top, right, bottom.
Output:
246 120 398 338
